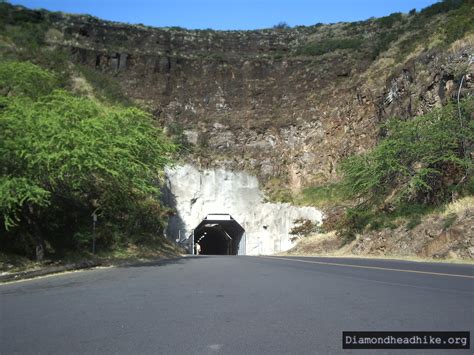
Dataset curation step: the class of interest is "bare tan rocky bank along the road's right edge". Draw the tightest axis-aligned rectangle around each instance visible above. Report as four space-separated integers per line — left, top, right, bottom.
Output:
284 197 474 262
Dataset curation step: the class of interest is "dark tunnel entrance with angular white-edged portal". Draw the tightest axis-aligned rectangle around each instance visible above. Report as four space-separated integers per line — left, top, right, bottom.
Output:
194 214 245 255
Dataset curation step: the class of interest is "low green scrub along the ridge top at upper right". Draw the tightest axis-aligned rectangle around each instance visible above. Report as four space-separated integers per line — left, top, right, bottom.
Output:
295 0 474 60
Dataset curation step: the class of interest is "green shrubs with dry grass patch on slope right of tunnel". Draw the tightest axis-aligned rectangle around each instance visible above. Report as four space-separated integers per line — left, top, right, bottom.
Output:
300 98 474 245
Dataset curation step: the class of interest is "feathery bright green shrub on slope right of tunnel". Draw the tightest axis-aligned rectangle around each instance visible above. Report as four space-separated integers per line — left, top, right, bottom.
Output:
340 100 474 204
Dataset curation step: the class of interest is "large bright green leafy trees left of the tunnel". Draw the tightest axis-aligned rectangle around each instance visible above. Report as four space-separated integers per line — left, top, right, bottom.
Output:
0 62 174 258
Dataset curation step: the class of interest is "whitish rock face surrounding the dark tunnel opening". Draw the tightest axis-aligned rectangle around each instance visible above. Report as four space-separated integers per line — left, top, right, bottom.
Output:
165 165 322 255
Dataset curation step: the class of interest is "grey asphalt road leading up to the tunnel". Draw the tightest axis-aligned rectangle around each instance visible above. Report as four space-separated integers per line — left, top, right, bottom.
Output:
0 256 474 354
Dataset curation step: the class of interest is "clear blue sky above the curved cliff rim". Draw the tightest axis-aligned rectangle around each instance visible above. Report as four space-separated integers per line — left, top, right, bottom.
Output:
9 0 437 30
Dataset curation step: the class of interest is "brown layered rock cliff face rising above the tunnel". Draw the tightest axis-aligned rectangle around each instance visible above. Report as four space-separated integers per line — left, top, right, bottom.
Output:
9 3 474 189
